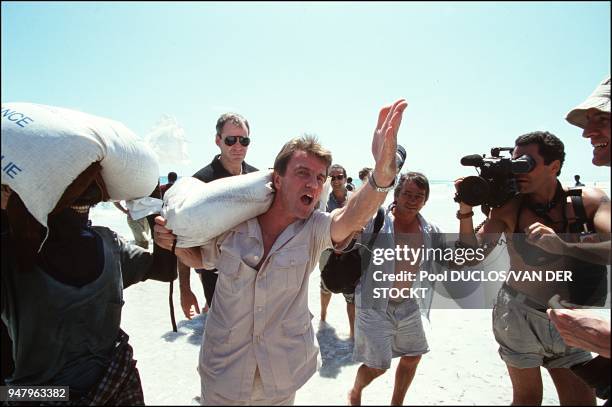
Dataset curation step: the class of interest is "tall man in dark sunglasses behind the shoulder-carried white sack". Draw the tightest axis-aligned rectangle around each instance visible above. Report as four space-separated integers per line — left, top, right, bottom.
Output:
178 113 257 319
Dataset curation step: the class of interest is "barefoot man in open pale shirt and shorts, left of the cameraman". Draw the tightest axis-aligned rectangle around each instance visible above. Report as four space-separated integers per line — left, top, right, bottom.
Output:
349 172 441 406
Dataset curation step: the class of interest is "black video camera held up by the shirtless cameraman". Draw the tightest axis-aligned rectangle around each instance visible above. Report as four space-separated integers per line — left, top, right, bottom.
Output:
455 147 535 208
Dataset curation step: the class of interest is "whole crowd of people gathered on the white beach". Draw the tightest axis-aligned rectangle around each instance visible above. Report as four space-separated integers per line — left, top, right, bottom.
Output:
2 76 610 405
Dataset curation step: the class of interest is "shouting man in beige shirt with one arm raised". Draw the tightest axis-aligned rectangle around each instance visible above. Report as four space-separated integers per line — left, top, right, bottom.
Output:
155 99 407 405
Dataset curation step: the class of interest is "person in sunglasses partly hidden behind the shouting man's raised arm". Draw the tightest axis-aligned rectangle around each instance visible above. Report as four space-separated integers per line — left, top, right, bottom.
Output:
319 164 355 338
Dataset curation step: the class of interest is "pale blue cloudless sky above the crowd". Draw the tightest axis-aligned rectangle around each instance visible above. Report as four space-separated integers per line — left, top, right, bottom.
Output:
1 1 610 180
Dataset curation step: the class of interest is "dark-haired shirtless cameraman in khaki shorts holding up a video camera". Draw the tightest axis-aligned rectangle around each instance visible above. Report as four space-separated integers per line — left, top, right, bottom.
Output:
455 131 610 405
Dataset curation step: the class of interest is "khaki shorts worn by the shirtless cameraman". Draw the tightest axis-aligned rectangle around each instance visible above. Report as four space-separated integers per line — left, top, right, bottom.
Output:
493 287 593 369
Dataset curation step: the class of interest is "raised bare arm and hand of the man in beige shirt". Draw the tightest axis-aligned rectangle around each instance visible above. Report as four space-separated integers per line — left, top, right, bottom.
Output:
331 99 408 243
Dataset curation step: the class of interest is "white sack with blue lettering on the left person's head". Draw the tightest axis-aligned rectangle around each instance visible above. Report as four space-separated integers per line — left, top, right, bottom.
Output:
1 103 159 227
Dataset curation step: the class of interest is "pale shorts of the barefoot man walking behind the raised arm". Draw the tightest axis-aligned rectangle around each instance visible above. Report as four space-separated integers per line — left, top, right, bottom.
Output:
353 300 429 370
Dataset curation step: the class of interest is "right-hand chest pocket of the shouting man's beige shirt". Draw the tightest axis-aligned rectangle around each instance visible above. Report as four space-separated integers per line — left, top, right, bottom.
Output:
272 246 309 290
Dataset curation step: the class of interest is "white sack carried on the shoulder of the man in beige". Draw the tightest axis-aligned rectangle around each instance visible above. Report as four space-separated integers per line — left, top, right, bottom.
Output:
162 170 274 247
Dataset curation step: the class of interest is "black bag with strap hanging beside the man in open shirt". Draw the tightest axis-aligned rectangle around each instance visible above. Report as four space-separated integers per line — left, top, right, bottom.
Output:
321 208 385 294
